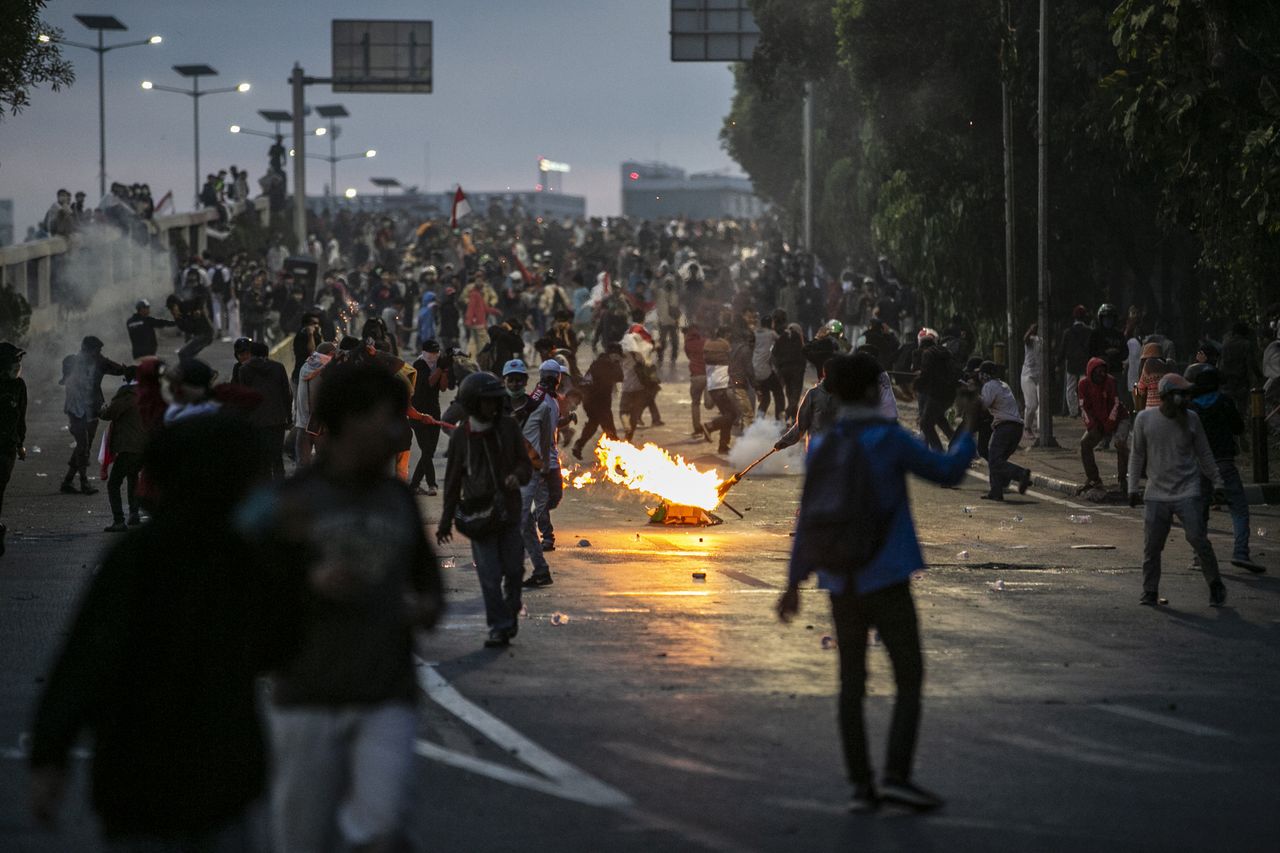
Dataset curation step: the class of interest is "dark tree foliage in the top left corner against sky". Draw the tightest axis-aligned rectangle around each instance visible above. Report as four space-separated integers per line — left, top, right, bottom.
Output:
0 0 76 122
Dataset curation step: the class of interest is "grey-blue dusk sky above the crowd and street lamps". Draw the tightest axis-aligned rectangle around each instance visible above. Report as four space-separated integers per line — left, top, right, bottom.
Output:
0 0 740 233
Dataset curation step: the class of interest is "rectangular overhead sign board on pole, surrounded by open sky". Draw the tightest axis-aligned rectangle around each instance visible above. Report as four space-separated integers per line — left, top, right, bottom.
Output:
332 20 431 95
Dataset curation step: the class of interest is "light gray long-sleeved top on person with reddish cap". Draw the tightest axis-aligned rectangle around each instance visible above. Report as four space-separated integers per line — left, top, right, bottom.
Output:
1129 409 1222 501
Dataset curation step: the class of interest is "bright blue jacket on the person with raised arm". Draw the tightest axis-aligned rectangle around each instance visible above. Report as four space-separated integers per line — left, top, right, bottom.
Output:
790 406 975 596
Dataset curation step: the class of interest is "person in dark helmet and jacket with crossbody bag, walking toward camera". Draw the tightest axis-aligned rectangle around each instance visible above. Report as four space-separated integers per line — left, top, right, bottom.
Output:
435 371 534 648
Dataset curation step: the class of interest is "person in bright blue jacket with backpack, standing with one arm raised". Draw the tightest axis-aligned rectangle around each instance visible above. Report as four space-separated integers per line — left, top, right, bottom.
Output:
777 355 975 812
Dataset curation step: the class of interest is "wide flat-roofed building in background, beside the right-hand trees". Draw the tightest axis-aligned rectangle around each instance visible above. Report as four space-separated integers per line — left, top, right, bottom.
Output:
622 161 764 219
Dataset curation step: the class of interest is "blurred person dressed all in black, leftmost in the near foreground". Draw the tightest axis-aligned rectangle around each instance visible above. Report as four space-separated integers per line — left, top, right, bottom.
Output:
29 415 275 850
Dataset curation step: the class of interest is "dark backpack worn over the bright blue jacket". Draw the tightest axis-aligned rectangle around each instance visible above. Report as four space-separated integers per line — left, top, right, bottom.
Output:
791 420 893 576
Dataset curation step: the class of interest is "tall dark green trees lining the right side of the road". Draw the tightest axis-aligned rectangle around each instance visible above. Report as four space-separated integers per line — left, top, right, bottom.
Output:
721 0 1280 343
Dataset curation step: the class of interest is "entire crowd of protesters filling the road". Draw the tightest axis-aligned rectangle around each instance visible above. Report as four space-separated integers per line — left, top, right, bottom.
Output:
0 201 1280 853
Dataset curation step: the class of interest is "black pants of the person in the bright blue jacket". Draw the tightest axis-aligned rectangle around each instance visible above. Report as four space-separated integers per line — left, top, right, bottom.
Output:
831 583 924 785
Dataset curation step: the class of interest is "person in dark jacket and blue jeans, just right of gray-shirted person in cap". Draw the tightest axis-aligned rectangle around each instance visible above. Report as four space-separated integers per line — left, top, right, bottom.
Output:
1185 364 1266 574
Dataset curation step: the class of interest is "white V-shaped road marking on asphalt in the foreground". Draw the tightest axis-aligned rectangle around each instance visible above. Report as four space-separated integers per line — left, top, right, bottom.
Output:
415 661 632 808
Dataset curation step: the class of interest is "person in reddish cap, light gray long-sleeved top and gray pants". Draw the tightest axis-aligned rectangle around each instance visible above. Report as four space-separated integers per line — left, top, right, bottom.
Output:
1129 373 1226 607
